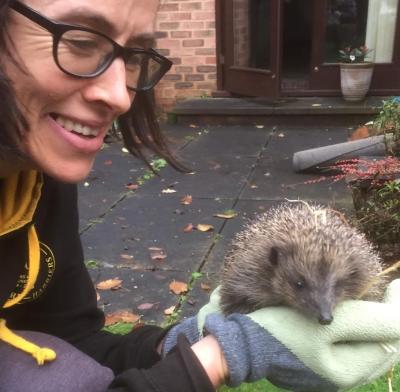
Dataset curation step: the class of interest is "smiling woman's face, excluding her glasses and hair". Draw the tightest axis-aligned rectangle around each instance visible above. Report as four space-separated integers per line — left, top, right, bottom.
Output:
6 0 158 182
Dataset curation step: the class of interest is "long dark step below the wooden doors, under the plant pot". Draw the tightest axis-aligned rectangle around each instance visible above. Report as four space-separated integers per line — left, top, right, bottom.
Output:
168 96 390 126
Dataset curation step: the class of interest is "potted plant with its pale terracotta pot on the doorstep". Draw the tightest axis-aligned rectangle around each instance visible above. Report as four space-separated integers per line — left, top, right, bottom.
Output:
339 46 374 102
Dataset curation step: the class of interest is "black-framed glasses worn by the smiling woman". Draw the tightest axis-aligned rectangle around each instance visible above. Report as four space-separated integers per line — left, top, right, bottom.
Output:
10 0 172 91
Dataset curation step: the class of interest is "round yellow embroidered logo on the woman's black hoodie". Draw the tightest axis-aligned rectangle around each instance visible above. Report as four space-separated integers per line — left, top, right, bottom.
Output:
9 242 56 304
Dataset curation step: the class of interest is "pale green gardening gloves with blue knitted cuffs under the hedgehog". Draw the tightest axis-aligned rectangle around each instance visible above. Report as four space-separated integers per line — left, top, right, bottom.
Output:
165 280 400 391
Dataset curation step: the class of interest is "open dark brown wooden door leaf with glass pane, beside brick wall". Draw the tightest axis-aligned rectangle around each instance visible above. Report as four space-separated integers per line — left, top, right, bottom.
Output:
220 0 281 98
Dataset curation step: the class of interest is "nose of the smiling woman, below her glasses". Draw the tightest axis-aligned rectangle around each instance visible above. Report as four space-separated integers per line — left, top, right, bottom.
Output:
84 58 135 115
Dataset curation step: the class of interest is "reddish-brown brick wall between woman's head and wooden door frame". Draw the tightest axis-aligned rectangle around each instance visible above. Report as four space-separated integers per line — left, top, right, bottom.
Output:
156 0 217 111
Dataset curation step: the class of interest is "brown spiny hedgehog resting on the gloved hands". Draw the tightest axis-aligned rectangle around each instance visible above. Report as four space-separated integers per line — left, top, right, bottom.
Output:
220 201 385 324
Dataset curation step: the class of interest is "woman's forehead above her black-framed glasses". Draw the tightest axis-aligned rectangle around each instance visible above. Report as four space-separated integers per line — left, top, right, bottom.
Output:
19 0 159 39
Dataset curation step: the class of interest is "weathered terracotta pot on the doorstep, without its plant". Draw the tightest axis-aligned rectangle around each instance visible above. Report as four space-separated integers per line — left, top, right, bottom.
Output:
340 62 374 102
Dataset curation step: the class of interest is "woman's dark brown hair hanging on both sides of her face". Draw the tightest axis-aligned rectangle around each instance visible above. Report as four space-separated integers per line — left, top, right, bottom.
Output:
0 0 188 171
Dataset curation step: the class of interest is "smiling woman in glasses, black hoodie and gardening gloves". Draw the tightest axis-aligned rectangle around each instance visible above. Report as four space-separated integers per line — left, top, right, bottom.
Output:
0 0 400 392
